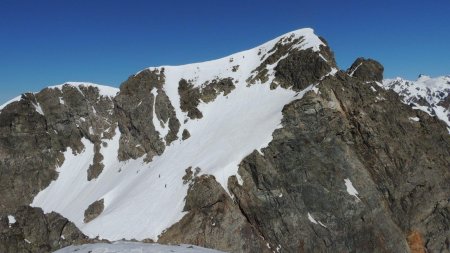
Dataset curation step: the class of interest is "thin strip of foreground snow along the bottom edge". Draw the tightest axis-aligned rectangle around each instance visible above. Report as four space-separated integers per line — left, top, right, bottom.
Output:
54 241 222 253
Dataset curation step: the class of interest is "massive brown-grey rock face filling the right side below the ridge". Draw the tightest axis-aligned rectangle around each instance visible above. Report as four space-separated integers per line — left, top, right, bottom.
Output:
229 73 450 252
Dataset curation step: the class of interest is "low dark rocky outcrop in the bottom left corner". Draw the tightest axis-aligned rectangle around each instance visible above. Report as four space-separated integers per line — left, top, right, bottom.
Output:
0 206 92 253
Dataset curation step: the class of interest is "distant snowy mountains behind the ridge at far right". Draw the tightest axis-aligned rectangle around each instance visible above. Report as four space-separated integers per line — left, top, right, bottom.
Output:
383 75 450 127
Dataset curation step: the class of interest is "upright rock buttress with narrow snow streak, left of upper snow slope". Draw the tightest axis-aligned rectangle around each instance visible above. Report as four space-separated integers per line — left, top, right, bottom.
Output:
115 69 180 161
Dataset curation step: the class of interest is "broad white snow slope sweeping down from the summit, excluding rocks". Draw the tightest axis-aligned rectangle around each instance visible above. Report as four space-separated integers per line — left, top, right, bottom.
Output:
32 29 335 240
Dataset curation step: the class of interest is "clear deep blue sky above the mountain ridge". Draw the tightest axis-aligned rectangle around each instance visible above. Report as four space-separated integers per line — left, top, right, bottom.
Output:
0 0 450 104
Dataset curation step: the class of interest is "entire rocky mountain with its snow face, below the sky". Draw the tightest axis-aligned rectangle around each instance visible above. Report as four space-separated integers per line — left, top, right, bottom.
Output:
0 29 450 252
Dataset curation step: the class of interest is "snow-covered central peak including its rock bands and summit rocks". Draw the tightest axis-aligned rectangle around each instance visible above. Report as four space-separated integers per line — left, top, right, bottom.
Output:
24 28 336 240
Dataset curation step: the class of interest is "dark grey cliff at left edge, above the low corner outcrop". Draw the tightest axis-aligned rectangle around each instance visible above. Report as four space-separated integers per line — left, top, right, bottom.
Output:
0 85 117 215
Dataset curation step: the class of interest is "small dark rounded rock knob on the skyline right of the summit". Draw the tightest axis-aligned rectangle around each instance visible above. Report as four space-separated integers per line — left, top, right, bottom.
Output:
347 58 384 82
